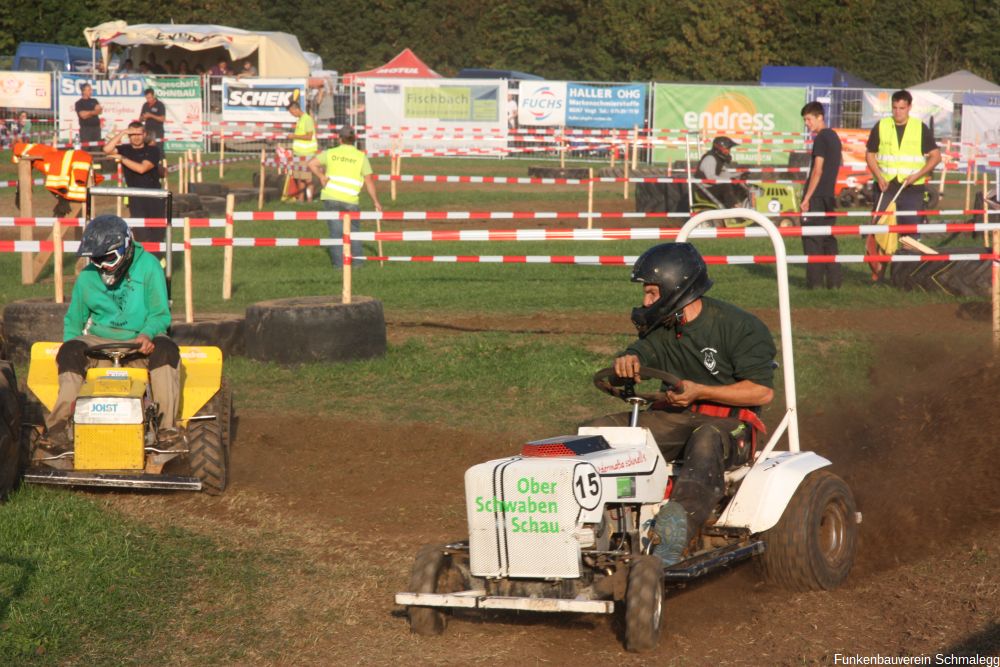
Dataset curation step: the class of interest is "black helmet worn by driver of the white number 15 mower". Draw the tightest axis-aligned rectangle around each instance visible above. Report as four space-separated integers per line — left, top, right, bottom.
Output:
632 243 712 337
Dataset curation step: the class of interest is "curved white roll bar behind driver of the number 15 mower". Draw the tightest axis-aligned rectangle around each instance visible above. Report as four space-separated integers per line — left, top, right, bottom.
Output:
677 208 799 460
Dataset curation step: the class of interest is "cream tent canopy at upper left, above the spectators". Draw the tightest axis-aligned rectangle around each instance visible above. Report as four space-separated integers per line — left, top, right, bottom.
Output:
83 21 309 77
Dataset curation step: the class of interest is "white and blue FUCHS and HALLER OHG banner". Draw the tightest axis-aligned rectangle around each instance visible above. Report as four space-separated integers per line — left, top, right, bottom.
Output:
517 81 646 129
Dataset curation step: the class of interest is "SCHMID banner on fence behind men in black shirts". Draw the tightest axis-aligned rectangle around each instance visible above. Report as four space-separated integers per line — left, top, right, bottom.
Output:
59 74 202 151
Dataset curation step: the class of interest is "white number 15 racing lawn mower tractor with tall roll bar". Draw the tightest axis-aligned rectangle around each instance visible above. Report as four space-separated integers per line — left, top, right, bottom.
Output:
396 209 861 651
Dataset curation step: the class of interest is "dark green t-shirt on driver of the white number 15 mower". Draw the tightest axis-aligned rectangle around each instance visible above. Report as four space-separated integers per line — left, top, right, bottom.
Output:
625 297 777 388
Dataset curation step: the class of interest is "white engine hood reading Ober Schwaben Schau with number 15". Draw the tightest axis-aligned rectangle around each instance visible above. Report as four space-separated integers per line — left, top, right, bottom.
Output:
465 428 669 579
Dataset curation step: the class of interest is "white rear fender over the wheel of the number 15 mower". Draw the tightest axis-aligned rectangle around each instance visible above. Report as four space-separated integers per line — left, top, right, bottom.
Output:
715 452 830 534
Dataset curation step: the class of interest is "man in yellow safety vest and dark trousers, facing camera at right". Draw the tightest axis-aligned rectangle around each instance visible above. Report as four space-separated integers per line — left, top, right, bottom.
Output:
865 90 941 225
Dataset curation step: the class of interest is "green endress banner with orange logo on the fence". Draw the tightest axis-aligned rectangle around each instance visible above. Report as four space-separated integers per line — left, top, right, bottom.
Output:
653 84 806 164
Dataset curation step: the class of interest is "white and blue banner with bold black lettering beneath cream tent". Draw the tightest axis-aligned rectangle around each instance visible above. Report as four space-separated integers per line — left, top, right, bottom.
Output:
222 78 306 123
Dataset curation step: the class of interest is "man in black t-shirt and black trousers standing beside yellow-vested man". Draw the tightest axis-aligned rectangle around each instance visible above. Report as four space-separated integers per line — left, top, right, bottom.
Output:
802 102 844 289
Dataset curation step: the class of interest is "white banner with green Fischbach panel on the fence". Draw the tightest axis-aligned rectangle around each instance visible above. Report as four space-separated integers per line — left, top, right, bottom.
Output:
365 78 507 155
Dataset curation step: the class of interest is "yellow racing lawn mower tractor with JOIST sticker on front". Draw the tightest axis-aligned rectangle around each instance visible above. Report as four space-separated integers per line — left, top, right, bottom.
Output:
24 342 233 495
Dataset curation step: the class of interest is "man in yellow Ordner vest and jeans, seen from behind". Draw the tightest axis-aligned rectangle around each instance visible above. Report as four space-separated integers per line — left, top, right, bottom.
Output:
309 125 382 268
